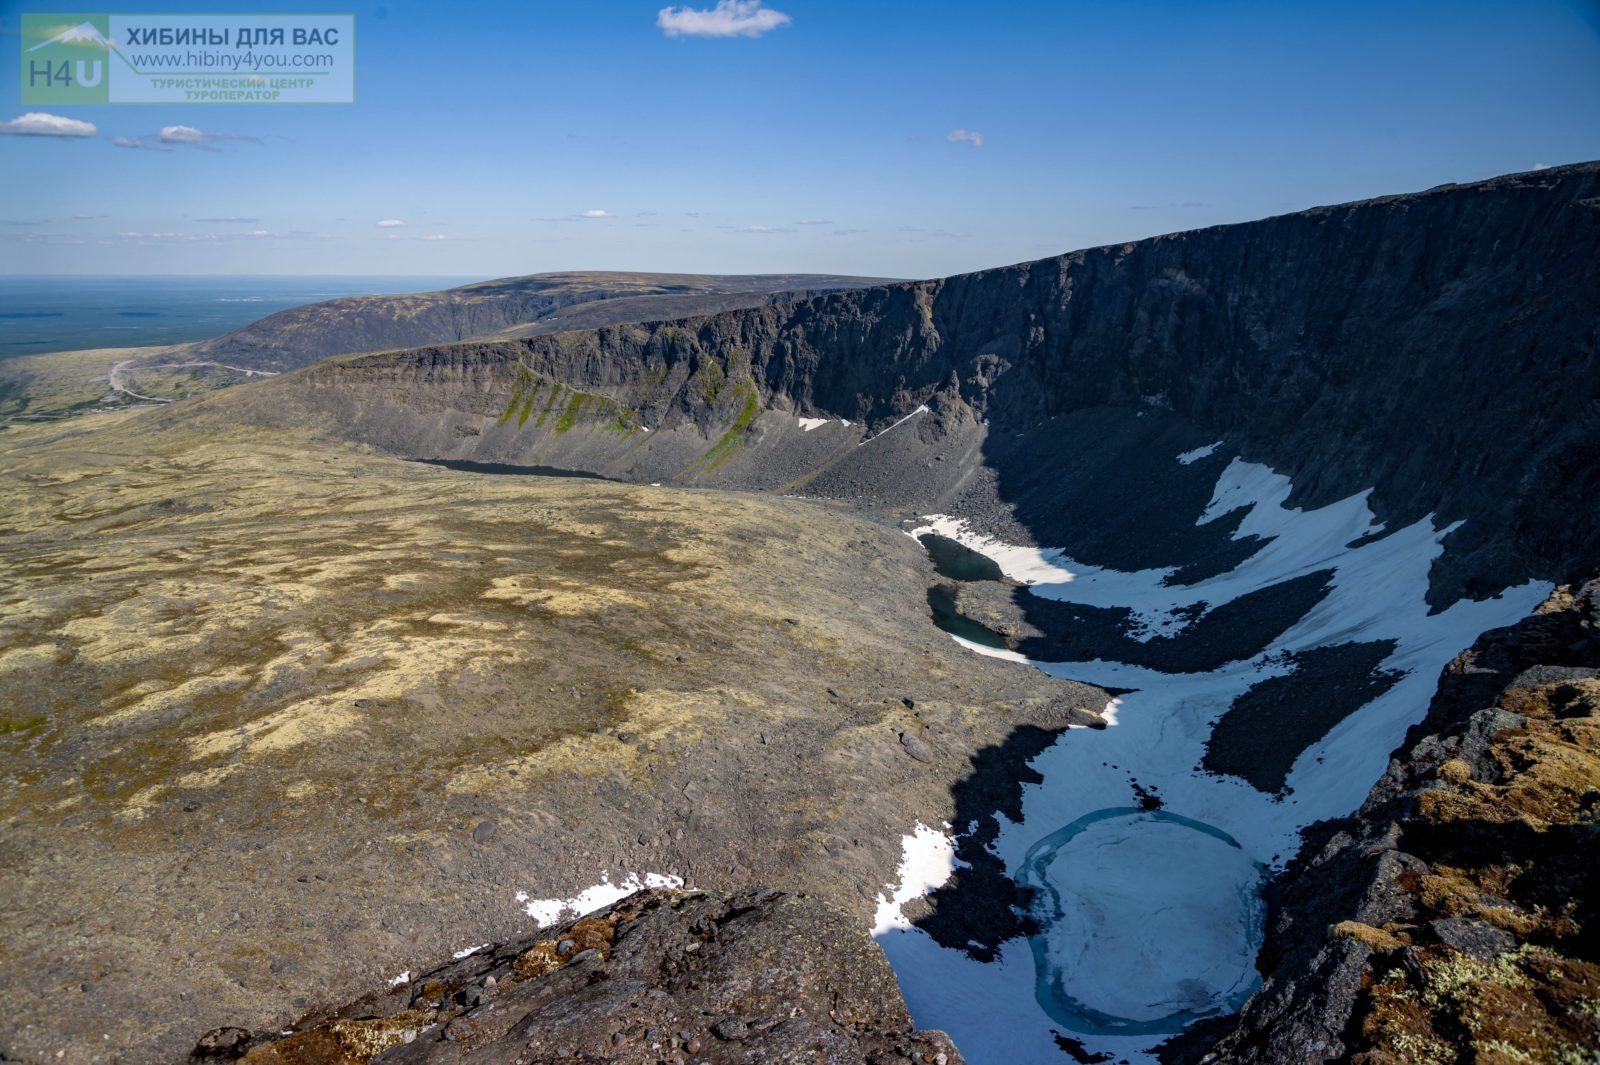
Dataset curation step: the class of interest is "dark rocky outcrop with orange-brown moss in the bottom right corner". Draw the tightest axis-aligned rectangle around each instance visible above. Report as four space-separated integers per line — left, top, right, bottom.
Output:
1165 580 1600 1065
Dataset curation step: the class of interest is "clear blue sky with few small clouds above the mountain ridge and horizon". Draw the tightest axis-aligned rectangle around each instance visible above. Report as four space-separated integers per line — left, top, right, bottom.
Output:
0 0 1600 277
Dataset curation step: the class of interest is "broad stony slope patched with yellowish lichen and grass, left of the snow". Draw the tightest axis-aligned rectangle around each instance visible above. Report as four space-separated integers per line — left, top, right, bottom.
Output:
0 408 1104 1065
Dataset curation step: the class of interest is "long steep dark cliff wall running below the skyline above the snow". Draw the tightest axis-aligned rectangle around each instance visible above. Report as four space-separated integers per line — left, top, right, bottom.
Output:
228 163 1600 604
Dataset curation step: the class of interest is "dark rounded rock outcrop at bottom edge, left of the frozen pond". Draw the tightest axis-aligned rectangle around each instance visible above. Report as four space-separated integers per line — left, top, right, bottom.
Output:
194 888 963 1065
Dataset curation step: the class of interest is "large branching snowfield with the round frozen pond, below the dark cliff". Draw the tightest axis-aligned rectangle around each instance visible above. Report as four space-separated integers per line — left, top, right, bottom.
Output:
874 449 1550 1065
